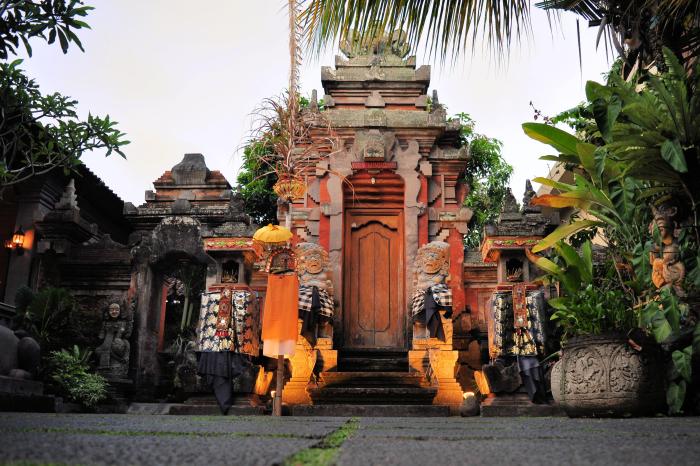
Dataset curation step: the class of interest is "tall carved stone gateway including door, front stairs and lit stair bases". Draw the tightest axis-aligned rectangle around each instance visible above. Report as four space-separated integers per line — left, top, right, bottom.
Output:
279 35 471 410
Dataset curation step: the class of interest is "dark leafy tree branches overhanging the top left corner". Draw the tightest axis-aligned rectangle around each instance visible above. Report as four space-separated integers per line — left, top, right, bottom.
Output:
0 0 129 196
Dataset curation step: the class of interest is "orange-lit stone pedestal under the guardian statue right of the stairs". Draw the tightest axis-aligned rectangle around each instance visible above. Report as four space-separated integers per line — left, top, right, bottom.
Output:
408 312 462 413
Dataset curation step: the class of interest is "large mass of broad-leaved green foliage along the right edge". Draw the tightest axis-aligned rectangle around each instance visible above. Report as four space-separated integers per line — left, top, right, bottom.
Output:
523 49 700 413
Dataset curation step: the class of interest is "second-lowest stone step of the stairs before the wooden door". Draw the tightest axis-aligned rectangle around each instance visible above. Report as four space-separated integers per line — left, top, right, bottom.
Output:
309 386 437 405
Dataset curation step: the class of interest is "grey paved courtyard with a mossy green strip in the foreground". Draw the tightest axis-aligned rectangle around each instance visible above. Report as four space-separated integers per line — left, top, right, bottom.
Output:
0 413 700 466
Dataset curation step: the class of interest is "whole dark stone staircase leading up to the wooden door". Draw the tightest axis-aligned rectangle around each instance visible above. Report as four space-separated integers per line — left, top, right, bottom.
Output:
291 351 449 417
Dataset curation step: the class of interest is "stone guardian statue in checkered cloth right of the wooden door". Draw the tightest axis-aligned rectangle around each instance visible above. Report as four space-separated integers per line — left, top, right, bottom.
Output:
411 241 452 341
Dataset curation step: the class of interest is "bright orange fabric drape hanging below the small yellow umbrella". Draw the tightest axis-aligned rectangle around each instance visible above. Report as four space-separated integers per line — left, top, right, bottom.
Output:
262 273 299 357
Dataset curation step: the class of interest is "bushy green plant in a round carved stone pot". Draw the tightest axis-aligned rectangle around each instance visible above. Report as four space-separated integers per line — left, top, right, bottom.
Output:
533 240 664 416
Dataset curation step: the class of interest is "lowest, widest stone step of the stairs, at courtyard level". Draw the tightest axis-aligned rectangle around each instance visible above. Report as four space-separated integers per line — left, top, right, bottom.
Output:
286 404 450 417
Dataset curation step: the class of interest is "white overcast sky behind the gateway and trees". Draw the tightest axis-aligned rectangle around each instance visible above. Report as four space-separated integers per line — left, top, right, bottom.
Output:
15 0 609 205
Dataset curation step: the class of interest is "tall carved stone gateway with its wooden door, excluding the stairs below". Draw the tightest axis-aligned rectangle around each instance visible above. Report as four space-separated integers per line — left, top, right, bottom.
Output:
288 35 471 352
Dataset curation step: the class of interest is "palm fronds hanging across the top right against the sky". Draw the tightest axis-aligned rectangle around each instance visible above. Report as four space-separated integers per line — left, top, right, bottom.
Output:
302 0 700 70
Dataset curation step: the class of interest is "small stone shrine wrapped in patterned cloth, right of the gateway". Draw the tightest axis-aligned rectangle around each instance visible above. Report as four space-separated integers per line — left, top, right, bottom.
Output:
475 180 553 408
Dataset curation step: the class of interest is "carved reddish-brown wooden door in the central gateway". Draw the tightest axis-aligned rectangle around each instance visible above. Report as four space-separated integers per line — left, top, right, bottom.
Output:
343 209 406 349
